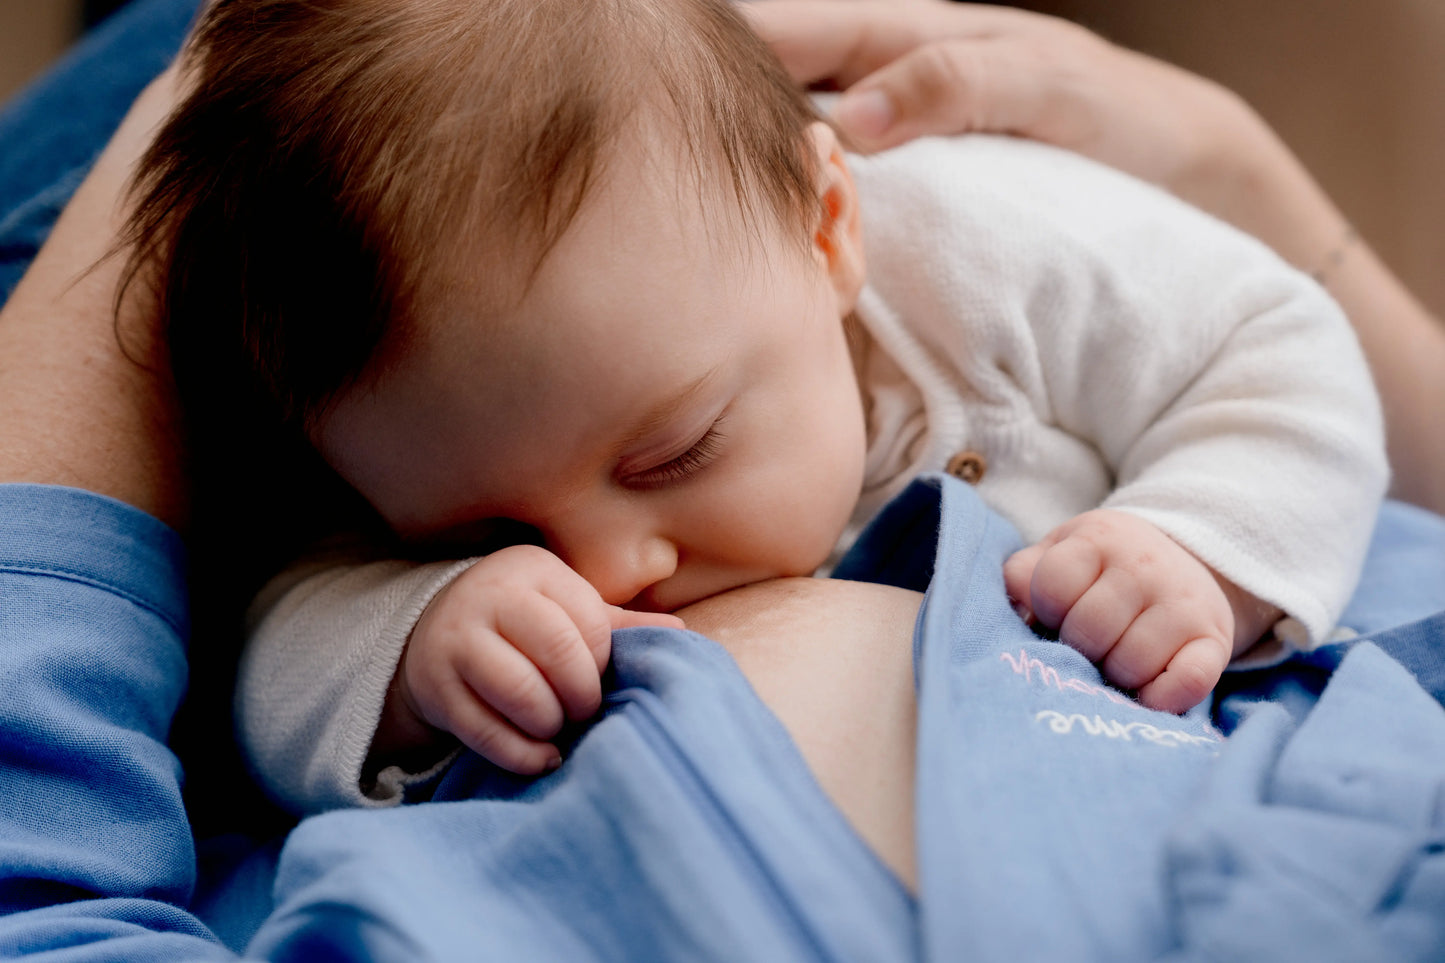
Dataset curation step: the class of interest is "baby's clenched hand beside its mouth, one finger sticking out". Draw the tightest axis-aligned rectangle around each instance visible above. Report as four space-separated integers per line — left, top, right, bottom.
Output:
373 545 682 775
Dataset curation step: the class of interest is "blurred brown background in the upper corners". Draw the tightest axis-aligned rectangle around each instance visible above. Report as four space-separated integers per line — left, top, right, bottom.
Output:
0 0 1445 317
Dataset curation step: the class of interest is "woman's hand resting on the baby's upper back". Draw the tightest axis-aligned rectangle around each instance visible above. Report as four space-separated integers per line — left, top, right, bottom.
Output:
747 0 1254 203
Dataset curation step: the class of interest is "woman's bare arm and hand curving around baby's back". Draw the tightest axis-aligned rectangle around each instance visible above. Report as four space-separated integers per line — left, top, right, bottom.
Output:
747 0 1445 513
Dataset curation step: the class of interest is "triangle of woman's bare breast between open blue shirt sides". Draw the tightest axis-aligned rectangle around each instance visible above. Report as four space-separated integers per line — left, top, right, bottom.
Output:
678 578 922 889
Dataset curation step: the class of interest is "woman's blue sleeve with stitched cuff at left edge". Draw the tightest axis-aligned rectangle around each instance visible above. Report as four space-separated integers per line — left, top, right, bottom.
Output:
0 484 225 960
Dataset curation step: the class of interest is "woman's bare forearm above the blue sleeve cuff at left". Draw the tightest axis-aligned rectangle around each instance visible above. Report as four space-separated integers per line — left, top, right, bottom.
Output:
0 71 186 528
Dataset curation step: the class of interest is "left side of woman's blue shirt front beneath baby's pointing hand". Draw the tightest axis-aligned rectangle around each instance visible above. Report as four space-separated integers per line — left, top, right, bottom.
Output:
251 629 918 960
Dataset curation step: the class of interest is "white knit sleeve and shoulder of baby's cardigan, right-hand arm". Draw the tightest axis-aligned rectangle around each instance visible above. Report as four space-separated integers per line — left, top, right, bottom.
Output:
854 137 1387 702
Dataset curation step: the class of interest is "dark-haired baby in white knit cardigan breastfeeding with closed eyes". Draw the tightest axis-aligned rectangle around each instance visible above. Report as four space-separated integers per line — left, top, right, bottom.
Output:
134 0 1386 810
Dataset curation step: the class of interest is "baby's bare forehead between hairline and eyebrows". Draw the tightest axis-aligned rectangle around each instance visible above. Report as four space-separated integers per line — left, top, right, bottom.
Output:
393 165 822 409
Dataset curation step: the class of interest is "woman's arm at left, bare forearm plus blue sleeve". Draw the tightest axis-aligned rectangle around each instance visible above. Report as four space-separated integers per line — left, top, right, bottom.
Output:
0 56 242 960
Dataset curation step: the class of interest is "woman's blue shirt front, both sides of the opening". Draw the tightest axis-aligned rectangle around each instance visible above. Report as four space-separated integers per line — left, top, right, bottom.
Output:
213 479 1445 960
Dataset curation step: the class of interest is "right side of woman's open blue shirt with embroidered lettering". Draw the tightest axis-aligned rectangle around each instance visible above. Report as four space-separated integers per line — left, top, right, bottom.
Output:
845 479 1445 960
